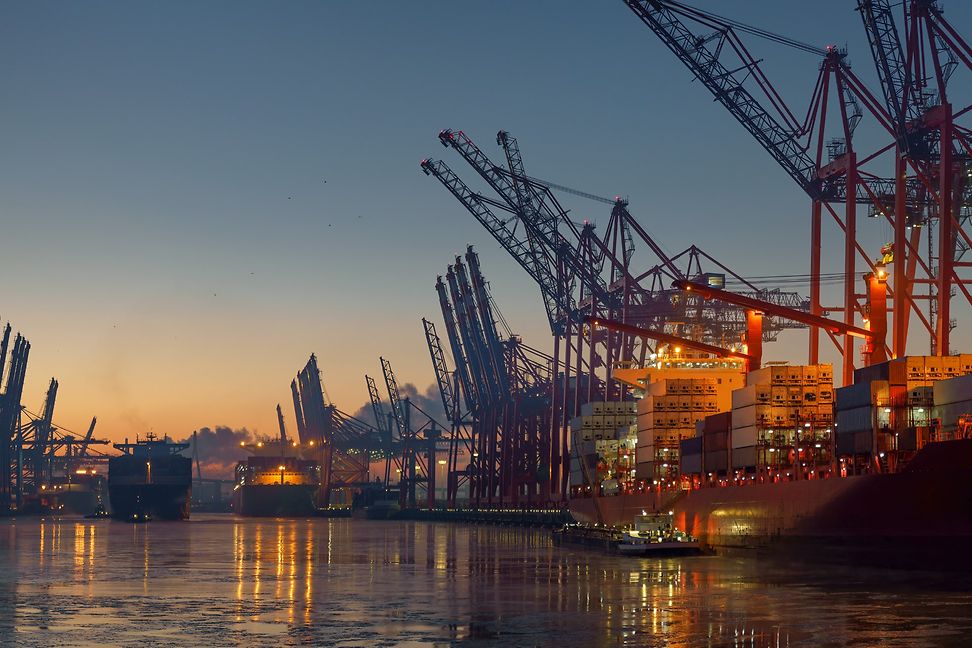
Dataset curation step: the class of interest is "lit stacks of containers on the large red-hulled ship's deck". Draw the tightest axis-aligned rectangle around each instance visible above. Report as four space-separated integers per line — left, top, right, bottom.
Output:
571 354 972 489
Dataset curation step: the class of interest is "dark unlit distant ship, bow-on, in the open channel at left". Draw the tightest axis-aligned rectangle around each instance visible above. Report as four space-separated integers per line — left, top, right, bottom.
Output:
108 434 192 521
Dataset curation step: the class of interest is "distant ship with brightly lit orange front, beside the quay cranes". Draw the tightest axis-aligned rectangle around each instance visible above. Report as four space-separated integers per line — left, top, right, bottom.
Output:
233 437 321 517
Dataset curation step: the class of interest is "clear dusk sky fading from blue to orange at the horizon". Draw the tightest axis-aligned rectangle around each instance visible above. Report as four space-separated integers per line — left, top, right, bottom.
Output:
0 0 972 440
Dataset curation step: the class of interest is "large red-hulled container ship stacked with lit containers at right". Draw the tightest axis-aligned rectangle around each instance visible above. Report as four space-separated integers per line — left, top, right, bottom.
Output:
570 355 972 570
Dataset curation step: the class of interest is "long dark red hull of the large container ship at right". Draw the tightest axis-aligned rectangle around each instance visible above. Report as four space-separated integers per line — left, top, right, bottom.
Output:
570 440 972 571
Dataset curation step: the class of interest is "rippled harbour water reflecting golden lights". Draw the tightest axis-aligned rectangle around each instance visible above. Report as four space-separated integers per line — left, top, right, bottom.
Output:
0 515 972 648
